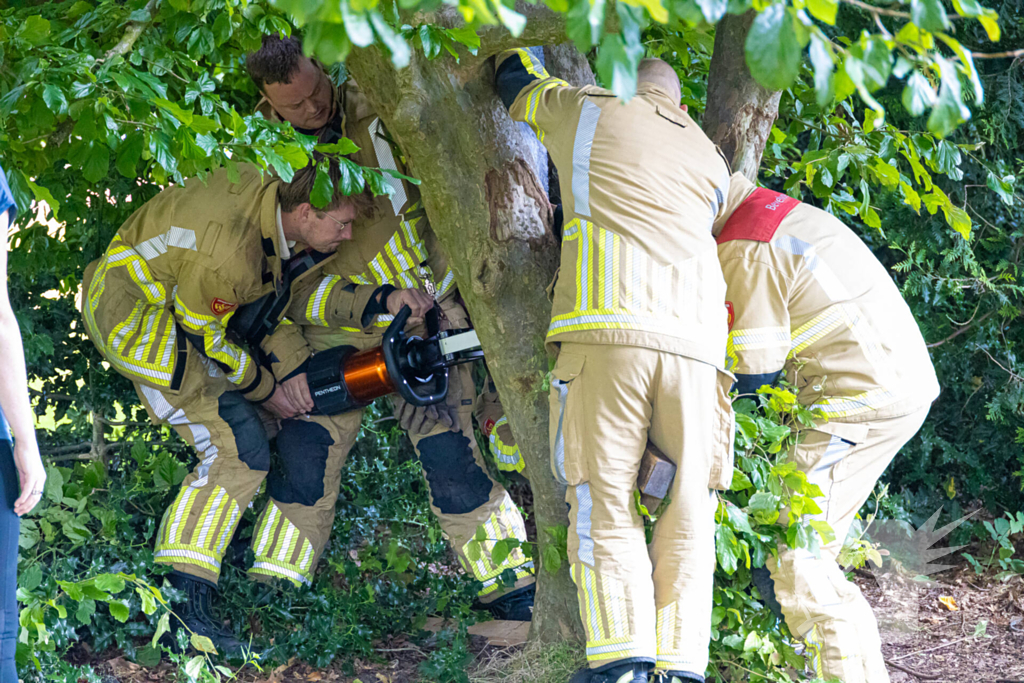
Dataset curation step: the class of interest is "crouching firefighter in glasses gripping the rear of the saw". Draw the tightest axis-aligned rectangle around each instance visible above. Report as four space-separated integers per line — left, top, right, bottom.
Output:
82 158 374 652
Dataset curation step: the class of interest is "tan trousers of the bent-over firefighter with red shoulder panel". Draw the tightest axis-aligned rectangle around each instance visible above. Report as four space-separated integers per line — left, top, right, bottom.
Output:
767 408 929 683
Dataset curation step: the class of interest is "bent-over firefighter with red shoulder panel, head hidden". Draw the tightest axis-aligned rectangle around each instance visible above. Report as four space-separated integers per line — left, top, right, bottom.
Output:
715 174 939 683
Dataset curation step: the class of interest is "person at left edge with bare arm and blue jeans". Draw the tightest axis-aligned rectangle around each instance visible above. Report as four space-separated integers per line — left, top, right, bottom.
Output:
0 162 46 683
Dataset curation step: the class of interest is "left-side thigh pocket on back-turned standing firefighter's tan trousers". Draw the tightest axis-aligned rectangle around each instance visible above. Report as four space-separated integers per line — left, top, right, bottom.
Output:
549 352 587 486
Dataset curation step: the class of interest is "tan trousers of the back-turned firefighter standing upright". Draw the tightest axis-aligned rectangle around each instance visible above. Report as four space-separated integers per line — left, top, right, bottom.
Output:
550 342 733 676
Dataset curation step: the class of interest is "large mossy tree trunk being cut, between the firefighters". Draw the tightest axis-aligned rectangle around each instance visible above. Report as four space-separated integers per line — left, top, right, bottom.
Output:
347 28 582 642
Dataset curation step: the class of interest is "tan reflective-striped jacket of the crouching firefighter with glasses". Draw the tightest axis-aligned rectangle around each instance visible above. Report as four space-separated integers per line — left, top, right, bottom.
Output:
82 165 329 401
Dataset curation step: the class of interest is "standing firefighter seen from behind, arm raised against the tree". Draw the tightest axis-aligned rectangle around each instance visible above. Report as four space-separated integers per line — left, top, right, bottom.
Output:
496 50 733 683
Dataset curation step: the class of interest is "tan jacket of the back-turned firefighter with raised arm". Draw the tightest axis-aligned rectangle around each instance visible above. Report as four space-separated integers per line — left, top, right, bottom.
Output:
498 50 729 368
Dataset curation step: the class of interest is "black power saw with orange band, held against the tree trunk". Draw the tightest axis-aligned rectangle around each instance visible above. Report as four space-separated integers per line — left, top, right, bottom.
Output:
306 306 483 415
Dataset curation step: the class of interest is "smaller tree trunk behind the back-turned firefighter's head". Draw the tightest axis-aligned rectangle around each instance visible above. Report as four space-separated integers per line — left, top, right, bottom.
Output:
703 11 782 180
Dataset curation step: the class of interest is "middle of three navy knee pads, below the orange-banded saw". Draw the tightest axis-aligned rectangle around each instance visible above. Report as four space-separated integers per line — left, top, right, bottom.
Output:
266 420 334 505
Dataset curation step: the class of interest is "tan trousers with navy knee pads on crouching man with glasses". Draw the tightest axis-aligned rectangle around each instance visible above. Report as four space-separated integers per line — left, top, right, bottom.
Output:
136 378 361 585
